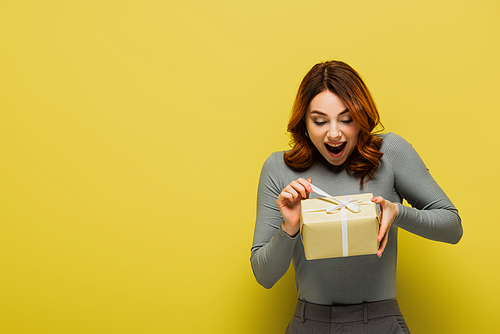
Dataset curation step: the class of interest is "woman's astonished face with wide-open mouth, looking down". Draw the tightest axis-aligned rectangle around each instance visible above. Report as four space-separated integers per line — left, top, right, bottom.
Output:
305 90 359 166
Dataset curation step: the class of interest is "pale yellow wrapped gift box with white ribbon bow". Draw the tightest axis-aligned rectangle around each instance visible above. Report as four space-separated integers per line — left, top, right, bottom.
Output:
300 186 379 260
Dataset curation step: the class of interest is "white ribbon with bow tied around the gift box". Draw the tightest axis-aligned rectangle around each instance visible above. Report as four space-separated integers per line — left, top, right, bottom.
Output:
302 184 375 257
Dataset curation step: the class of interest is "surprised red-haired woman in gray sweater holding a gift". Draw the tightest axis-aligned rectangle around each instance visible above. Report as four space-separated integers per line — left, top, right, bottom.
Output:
251 61 462 333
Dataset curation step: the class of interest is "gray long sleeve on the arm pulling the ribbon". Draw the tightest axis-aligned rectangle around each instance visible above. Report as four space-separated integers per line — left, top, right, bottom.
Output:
250 154 299 289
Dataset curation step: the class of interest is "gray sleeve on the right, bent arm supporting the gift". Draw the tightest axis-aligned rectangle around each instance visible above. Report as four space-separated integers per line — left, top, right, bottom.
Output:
384 133 463 244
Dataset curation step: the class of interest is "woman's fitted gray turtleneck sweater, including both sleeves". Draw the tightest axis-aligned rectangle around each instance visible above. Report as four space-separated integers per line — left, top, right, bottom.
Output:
251 133 462 305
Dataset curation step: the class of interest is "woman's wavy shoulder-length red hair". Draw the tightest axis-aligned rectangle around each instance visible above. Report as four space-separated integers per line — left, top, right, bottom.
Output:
284 61 383 185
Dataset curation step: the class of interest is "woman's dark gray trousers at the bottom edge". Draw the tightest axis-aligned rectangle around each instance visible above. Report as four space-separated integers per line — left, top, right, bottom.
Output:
285 299 410 334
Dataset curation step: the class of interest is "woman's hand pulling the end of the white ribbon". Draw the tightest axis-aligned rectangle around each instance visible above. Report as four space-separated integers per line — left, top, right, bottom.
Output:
276 178 313 237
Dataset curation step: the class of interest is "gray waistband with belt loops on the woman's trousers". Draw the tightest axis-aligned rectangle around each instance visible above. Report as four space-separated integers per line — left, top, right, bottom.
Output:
294 299 402 323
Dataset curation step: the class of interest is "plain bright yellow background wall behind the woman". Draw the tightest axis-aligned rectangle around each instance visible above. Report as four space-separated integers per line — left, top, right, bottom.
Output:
0 0 500 334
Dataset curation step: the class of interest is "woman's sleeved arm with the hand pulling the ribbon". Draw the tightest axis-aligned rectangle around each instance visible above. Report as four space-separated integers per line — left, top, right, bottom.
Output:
250 154 308 288
